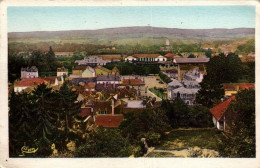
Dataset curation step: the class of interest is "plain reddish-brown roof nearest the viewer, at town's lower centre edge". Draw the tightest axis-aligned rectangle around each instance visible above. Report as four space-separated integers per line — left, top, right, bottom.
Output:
95 114 124 128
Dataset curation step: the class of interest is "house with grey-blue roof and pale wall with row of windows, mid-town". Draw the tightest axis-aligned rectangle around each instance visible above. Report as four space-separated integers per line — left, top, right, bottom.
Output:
96 75 121 91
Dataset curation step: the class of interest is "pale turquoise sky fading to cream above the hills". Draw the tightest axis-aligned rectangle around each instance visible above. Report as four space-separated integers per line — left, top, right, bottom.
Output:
7 6 255 32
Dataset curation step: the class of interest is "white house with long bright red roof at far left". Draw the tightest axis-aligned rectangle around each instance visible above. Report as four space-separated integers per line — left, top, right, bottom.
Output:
14 78 48 92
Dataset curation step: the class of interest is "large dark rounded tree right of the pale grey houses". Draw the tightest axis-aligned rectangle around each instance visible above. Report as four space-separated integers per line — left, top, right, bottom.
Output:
196 53 243 108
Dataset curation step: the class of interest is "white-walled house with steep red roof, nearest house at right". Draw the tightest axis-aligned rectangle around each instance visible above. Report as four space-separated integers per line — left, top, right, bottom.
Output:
210 96 235 131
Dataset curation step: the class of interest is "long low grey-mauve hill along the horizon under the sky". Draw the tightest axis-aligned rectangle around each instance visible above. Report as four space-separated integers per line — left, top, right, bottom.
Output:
8 26 255 45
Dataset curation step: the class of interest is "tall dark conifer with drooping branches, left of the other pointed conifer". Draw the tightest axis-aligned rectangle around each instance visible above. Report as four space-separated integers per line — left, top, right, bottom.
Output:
31 83 58 156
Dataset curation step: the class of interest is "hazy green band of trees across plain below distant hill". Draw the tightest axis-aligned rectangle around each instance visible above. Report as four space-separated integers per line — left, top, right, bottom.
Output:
8 39 255 55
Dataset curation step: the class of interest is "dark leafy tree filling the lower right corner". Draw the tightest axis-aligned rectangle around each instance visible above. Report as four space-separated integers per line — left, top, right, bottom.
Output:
217 89 256 157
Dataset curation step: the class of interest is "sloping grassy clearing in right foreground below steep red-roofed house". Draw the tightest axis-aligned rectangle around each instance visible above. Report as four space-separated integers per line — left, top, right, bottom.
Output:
157 128 223 150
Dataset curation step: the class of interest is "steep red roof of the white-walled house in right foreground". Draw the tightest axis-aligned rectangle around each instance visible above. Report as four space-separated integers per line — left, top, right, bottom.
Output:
210 96 235 121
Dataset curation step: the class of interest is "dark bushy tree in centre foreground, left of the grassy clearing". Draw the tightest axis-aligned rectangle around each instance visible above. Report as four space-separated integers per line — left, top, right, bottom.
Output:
119 109 170 145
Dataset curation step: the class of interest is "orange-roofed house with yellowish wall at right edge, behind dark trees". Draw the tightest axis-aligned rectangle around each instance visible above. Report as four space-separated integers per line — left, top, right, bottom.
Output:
222 83 255 96
